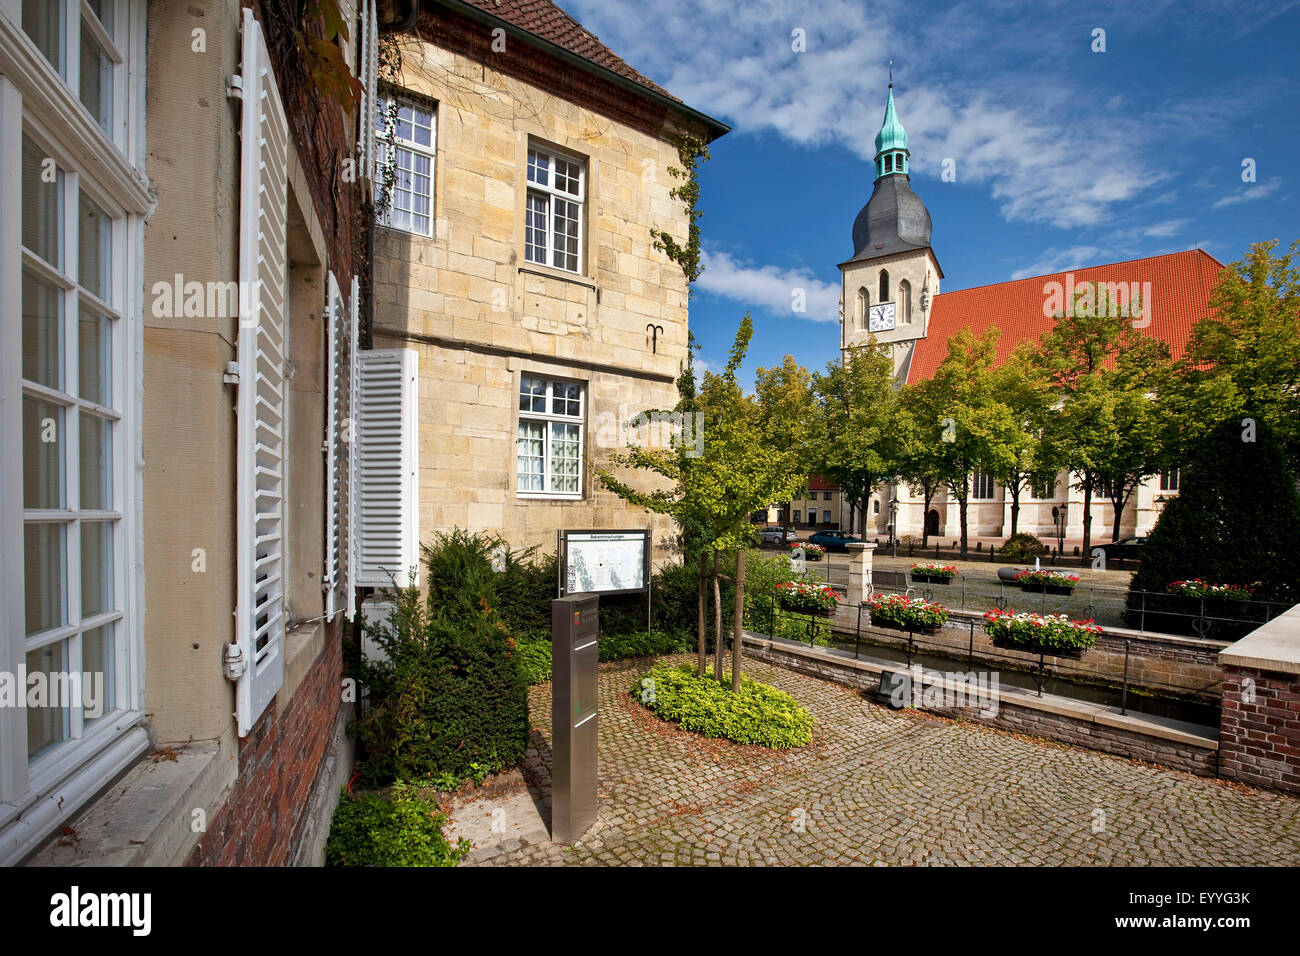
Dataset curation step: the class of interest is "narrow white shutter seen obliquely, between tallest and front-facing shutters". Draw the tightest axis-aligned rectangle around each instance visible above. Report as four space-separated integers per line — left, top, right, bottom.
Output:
322 272 356 620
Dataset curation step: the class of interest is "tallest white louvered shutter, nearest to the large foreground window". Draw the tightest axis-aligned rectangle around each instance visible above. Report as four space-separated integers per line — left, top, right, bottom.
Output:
235 8 289 736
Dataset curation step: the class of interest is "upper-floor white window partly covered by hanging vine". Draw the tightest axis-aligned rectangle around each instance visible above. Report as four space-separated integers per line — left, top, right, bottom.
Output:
374 94 438 237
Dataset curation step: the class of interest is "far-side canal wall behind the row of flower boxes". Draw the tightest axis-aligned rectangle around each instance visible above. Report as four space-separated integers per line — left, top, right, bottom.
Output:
831 605 1229 701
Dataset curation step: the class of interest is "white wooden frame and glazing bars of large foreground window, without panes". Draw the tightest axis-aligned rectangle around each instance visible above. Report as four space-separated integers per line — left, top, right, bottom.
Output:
0 0 152 865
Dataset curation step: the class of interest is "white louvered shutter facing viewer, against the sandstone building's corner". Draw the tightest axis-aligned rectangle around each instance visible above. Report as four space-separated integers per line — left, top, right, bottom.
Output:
354 349 420 588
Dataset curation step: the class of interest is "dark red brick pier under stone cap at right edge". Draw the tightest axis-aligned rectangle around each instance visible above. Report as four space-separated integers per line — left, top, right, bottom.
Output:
1219 665 1300 793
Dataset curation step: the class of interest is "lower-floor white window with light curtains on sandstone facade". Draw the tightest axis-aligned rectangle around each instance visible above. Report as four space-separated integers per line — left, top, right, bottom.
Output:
515 373 586 498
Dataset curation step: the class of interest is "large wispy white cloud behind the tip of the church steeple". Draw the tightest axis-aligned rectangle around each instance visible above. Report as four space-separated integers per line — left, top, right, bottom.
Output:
567 0 1190 228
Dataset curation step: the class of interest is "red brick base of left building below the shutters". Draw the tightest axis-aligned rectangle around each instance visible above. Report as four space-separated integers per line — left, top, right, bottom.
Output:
186 620 343 866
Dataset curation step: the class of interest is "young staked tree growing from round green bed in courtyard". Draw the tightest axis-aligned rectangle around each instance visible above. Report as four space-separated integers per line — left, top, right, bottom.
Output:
597 313 803 692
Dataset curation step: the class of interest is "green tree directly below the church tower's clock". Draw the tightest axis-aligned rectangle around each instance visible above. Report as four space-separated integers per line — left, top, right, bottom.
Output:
813 336 904 538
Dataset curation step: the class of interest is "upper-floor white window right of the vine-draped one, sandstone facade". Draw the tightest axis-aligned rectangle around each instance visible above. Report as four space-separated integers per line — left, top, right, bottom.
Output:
524 147 586 273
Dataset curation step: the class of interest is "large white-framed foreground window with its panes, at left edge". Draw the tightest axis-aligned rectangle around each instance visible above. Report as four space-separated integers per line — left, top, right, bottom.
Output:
0 0 150 865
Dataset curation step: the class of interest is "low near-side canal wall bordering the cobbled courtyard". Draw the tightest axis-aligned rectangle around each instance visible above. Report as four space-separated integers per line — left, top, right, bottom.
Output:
745 633 1218 777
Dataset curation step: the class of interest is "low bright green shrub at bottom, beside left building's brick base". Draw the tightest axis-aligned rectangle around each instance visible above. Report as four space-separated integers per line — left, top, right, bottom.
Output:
325 782 471 866
